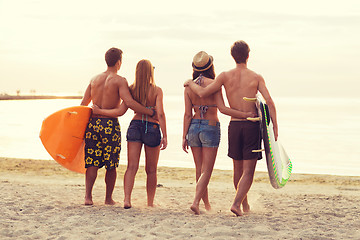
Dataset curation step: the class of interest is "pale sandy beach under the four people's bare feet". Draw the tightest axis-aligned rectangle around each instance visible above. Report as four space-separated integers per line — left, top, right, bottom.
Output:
0 158 360 239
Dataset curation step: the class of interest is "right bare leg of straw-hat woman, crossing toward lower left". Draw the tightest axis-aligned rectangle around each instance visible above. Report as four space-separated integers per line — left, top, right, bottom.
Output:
190 147 218 214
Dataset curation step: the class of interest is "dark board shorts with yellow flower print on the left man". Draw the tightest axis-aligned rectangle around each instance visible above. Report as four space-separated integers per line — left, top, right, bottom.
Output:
85 117 121 170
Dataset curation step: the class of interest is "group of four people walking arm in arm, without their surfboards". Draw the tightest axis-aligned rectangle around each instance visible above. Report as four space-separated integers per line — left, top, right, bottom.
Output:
81 41 278 216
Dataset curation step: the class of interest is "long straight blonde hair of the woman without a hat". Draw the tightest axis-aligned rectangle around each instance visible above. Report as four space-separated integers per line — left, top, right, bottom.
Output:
130 59 155 106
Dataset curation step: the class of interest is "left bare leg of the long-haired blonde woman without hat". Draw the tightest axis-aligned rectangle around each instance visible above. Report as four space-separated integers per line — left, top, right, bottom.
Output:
124 142 142 209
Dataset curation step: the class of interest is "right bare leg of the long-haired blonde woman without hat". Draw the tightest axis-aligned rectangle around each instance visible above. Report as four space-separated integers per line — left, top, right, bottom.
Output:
145 146 160 207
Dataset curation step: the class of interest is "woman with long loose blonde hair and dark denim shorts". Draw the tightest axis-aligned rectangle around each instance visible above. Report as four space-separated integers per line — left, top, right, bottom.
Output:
94 60 167 209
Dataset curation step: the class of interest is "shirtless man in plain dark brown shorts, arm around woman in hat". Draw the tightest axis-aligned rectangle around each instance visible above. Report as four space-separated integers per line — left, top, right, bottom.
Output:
184 41 278 216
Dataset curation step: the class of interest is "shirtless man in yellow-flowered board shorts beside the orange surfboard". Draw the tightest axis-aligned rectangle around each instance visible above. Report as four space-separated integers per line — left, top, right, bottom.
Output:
81 48 155 205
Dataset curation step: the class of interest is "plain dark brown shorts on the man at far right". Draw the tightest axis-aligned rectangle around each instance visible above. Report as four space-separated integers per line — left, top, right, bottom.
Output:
228 121 262 160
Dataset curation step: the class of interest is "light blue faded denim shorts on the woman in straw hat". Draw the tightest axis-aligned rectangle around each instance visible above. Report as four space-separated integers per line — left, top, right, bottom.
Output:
187 119 220 147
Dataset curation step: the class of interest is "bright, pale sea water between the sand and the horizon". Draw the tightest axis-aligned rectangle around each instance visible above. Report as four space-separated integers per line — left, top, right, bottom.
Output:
0 96 360 176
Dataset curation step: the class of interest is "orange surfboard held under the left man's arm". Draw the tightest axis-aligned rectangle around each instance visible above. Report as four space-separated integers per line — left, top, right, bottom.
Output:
40 106 91 173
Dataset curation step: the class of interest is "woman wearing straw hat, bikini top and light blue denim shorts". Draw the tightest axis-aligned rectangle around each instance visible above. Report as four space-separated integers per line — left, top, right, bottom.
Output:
182 51 254 215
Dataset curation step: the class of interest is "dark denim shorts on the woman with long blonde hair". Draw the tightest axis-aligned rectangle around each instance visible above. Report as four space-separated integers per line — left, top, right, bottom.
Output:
126 120 161 147
